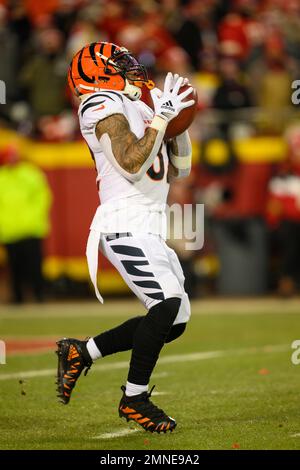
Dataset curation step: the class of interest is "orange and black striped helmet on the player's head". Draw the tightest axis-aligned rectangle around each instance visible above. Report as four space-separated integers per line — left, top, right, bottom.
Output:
68 42 152 96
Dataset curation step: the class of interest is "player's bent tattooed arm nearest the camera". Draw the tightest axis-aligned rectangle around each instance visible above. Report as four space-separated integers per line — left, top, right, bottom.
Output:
96 114 167 182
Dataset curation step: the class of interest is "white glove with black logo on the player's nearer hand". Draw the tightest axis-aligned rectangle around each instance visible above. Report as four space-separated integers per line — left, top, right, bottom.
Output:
150 72 195 122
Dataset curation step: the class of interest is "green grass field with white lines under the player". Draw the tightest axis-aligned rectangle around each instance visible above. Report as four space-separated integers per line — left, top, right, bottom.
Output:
0 299 300 450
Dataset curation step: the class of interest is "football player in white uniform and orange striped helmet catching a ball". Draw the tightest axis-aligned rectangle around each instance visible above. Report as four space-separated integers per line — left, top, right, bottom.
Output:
57 42 194 433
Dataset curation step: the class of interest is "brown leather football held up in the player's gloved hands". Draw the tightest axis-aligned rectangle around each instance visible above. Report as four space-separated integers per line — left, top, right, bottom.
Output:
165 84 198 140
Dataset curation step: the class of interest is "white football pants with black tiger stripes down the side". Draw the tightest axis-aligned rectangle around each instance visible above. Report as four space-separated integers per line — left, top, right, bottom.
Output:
100 233 191 325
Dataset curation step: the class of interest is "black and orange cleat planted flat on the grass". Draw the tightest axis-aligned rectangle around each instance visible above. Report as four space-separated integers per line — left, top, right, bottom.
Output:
119 385 177 433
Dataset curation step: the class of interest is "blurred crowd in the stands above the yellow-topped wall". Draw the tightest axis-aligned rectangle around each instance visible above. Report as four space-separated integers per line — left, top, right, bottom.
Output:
0 0 300 141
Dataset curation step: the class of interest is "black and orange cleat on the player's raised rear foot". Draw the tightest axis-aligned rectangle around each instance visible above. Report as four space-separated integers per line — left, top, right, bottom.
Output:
56 338 93 405
